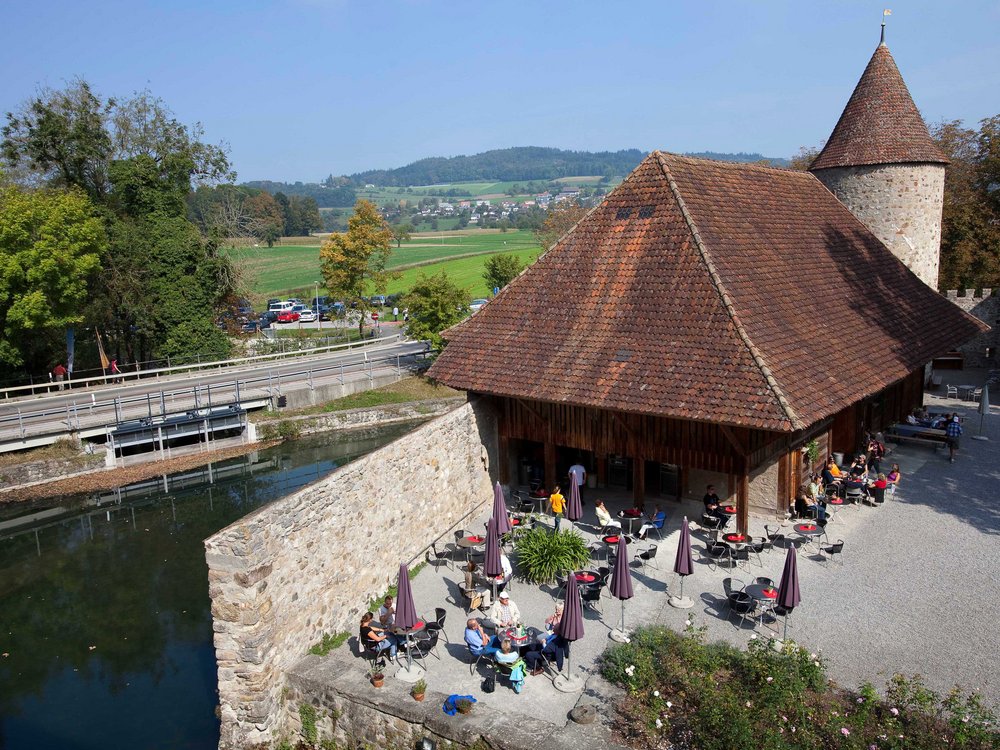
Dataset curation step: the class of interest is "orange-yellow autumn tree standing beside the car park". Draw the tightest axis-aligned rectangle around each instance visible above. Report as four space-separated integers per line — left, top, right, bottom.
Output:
319 199 392 336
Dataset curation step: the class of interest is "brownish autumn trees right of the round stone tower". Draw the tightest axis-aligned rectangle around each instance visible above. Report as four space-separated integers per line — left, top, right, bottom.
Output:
931 115 1000 289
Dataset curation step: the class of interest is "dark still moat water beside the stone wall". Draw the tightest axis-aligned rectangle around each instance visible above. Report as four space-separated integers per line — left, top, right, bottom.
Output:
0 426 412 750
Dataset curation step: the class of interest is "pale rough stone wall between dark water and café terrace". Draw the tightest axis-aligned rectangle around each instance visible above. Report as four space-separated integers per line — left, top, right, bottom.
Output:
205 402 497 748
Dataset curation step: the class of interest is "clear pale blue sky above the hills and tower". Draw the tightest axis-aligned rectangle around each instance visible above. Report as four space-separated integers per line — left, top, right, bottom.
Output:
0 0 1000 182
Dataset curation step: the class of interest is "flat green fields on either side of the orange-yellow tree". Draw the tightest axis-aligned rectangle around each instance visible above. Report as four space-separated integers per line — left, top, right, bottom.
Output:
227 230 541 301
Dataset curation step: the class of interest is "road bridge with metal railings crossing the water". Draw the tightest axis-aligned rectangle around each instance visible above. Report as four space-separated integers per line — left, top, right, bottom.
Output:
0 335 428 453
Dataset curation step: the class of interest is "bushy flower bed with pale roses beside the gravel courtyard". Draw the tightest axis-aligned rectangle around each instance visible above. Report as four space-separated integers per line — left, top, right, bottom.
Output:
601 620 1000 750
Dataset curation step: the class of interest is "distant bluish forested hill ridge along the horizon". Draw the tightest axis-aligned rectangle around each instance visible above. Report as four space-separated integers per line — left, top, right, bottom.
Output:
350 146 788 187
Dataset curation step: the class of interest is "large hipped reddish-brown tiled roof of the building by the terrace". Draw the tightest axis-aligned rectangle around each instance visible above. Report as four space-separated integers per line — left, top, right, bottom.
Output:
430 152 983 431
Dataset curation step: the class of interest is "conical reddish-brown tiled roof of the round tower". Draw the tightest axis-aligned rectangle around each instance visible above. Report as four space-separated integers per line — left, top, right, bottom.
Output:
809 44 948 170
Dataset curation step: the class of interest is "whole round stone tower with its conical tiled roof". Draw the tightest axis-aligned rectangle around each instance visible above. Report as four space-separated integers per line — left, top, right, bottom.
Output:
809 41 948 290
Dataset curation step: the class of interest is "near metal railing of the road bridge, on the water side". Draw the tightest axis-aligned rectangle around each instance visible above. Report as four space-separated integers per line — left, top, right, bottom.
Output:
0 342 427 445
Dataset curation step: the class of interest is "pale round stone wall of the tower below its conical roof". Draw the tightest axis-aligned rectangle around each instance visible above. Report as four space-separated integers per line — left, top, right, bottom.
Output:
813 164 944 291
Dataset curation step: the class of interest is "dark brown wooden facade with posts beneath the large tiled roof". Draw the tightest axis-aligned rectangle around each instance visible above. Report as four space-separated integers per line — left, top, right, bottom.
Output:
481 370 923 529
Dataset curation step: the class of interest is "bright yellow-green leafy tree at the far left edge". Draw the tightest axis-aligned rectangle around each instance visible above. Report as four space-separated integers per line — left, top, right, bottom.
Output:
0 186 107 371
